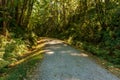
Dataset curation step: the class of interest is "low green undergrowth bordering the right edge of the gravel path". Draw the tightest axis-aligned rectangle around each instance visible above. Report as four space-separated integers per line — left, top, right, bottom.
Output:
67 38 120 68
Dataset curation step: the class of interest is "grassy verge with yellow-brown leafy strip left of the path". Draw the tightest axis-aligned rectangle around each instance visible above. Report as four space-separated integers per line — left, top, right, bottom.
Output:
0 38 44 80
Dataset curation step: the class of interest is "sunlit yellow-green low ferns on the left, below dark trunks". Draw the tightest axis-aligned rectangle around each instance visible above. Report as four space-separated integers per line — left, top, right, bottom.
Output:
0 35 28 70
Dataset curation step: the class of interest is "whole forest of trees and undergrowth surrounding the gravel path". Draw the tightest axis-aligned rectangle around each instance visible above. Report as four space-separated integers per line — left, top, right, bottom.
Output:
0 0 120 80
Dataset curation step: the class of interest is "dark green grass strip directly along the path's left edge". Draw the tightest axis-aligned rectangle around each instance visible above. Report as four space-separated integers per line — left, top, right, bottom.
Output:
0 54 43 80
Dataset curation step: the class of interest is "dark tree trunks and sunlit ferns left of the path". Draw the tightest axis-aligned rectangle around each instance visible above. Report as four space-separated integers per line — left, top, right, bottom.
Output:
0 0 35 72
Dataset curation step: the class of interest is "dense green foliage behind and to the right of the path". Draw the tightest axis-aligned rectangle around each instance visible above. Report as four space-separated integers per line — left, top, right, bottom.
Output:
30 0 120 64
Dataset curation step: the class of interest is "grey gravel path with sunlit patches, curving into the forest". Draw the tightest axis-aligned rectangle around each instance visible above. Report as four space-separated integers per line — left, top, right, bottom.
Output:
27 40 120 80
